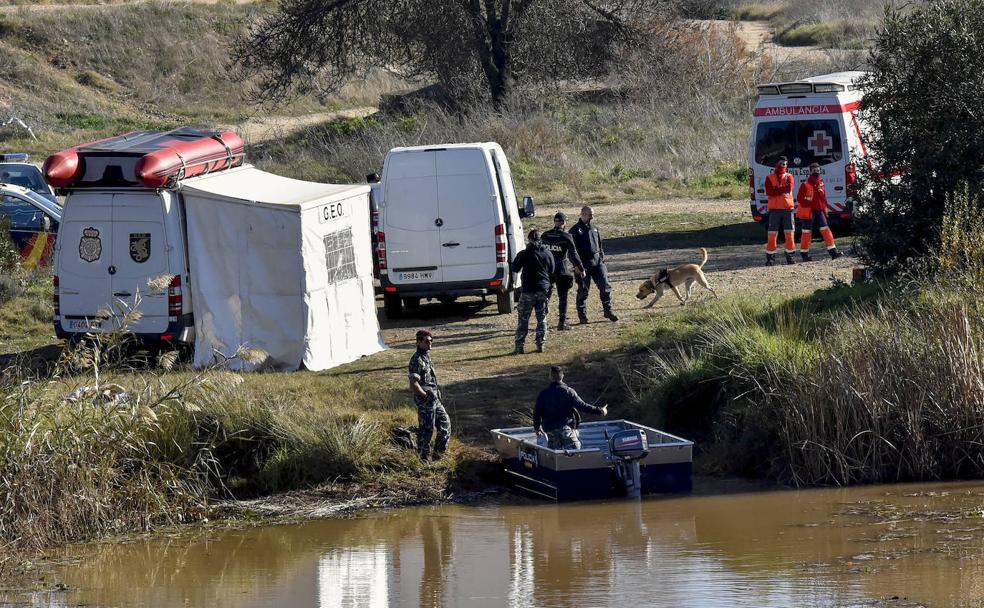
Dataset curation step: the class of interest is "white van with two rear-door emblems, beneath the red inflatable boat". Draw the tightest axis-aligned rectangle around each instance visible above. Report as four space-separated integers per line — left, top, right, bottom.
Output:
54 188 195 344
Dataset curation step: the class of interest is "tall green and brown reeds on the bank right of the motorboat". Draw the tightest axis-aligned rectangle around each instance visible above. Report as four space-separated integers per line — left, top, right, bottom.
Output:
630 284 984 486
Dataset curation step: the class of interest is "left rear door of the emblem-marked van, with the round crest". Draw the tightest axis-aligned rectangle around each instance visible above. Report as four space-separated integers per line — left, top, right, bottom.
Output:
55 192 113 332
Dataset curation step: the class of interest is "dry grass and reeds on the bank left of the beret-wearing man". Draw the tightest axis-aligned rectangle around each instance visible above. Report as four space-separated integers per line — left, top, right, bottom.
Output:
0 337 416 562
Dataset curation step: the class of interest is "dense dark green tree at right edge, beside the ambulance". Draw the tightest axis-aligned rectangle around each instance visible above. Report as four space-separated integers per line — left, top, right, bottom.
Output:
858 0 984 271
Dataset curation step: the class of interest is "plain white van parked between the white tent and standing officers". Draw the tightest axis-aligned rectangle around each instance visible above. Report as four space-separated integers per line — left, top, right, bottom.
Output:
373 142 535 318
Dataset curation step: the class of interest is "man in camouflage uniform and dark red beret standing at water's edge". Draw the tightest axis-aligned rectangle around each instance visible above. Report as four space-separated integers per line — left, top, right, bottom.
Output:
410 329 451 460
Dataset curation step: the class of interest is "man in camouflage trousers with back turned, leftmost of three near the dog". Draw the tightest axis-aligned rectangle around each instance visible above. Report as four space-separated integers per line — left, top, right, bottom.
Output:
512 229 554 355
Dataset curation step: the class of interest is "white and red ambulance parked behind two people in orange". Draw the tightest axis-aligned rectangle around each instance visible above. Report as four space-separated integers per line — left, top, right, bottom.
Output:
748 72 871 225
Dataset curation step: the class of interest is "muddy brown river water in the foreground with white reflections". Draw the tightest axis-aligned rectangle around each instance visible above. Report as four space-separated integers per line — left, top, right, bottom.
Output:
15 483 984 608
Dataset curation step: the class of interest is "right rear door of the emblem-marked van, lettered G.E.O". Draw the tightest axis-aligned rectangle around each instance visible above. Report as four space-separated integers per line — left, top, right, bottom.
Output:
112 193 169 334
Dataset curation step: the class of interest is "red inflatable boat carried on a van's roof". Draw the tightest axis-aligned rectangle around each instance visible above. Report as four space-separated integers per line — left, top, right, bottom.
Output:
42 127 245 188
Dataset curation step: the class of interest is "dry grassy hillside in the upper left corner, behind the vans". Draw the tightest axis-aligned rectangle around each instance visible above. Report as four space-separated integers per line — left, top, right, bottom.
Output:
0 1 406 155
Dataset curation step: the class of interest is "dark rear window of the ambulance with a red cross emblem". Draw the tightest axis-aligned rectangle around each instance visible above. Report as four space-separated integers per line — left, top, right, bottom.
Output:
755 120 844 168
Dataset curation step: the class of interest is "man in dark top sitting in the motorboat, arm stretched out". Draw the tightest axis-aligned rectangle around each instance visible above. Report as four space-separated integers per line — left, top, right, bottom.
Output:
533 365 608 450
